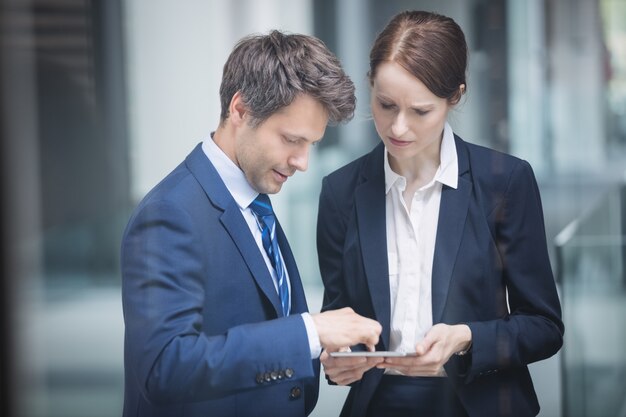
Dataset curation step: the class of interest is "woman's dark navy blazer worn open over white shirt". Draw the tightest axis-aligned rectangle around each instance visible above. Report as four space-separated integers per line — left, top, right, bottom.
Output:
317 136 563 417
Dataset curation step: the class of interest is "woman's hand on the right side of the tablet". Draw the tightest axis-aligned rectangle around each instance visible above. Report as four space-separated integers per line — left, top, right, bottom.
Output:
377 323 472 376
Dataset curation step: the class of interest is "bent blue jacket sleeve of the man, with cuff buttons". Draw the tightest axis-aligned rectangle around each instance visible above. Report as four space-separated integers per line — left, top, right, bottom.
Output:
121 201 316 404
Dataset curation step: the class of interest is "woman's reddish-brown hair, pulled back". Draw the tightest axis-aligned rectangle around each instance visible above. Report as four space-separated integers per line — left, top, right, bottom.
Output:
368 11 467 104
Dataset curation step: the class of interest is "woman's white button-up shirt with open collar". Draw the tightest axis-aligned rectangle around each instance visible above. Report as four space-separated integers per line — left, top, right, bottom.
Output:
384 123 459 360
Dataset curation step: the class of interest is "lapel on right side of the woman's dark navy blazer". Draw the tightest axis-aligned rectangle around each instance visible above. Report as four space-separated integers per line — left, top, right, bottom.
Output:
432 136 473 324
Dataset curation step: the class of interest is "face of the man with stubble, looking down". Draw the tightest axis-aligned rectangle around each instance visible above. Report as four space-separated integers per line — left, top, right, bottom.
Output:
234 94 328 194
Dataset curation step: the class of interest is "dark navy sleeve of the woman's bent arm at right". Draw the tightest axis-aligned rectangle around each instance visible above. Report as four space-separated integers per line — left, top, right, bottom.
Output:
466 160 564 382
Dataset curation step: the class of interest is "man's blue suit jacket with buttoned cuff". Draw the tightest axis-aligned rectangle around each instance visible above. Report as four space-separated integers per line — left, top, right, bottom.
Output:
121 145 319 417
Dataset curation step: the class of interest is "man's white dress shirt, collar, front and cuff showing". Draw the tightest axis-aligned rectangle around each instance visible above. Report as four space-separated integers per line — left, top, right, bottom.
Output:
202 134 322 359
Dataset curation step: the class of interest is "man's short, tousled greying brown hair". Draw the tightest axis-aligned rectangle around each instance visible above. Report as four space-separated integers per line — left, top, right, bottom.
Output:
220 30 356 127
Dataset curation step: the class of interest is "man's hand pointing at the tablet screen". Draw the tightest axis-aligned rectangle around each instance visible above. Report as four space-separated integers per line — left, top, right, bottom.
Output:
311 307 382 352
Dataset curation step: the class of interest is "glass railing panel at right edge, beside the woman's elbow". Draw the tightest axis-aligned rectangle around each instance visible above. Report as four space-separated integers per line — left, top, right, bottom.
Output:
556 186 626 417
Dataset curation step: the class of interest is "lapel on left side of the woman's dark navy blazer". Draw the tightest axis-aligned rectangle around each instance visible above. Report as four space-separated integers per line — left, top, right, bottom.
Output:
355 145 391 348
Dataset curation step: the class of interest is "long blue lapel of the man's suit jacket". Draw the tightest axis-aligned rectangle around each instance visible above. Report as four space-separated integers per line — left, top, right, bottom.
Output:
185 144 282 317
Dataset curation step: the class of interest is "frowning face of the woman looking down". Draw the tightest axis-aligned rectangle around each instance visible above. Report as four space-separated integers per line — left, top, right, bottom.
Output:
371 61 451 164
